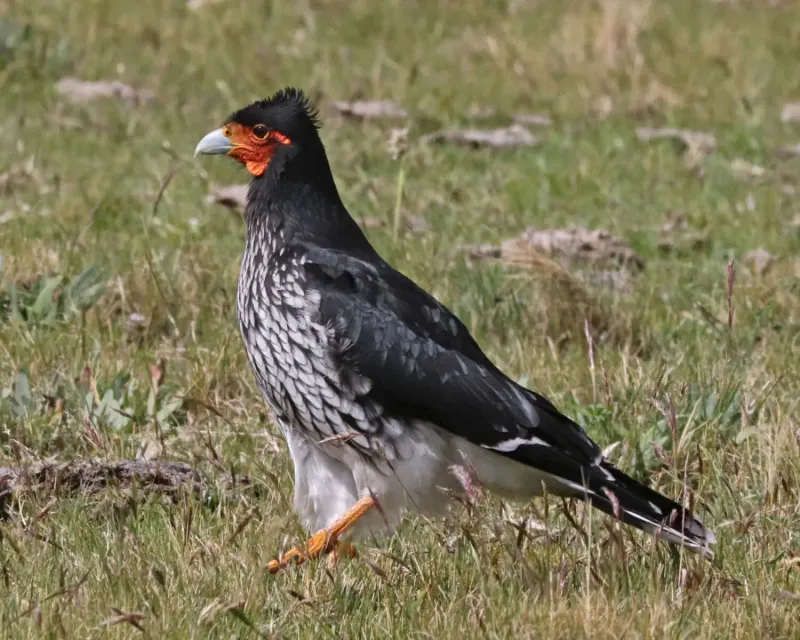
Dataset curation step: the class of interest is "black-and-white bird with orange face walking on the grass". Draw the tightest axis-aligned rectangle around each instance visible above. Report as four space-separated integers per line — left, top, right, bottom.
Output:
195 87 716 573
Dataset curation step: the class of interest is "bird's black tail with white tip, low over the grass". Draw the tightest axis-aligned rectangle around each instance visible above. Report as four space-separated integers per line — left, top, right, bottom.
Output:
584 461 717 557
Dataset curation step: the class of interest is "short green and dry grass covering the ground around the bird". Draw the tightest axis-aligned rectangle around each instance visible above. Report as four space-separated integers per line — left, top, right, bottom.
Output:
0 0 800 638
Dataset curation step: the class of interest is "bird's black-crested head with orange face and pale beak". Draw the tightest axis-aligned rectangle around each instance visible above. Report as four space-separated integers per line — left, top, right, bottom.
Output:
194 88 324 178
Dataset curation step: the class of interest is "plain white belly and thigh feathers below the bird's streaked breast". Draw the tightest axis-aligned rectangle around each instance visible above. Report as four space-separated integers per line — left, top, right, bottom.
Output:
284 425 561 538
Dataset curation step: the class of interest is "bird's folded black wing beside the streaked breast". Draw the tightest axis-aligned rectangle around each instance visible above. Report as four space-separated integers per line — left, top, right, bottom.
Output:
305 248 601 468
